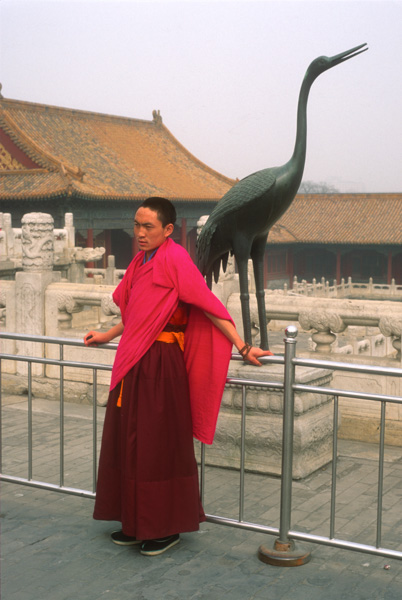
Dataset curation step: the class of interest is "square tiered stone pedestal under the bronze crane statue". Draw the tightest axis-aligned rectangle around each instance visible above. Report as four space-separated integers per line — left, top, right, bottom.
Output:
201 363 333 479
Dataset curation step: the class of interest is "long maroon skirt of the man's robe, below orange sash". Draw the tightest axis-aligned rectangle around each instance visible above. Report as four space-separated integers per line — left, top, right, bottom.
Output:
94 342 205 540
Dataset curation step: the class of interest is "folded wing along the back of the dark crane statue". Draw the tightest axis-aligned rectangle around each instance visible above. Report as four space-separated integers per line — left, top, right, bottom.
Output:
197 169 276 273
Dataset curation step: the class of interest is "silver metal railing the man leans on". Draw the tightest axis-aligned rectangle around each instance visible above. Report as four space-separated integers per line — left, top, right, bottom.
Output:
0 326 402 565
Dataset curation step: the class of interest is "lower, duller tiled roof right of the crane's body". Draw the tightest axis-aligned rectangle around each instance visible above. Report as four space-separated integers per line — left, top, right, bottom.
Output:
268 194 402 245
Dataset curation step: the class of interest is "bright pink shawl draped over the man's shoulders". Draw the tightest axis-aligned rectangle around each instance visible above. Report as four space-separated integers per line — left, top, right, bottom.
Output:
110 238 232 444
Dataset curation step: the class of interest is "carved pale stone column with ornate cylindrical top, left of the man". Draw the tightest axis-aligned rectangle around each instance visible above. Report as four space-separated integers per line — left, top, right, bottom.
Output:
15 213 61 375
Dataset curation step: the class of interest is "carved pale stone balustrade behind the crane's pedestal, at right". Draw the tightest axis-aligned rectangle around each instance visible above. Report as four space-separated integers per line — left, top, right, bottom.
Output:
227 294 402 446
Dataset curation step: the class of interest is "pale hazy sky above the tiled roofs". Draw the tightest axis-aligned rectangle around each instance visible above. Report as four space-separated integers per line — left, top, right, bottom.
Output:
0 0 402 192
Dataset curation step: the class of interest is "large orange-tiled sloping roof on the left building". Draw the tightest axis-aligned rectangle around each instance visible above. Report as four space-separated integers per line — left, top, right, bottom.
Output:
0 98 235 202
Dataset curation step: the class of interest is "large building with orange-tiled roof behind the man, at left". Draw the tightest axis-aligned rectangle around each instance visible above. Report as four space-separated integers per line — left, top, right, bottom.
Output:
0 98 235 268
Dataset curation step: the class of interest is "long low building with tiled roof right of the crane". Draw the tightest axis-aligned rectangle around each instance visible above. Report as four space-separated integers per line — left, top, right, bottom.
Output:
266 194 402 287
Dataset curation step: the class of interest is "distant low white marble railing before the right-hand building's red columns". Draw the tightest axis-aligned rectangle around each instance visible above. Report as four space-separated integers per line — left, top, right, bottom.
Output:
283 276 402 300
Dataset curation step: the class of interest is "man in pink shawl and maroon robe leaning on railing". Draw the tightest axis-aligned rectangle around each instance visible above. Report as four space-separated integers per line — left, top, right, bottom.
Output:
84 198 271 556
